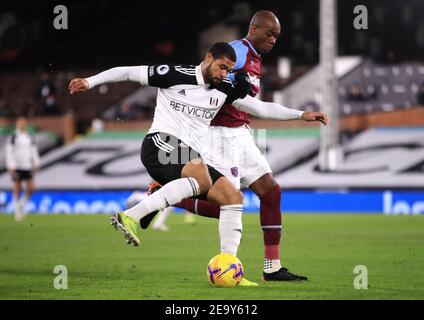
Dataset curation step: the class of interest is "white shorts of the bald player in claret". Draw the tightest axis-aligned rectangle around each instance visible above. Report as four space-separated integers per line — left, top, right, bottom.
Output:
199 126 272 189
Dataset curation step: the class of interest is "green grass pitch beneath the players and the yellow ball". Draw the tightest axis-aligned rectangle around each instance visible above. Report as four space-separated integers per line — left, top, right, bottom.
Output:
0 214 424 300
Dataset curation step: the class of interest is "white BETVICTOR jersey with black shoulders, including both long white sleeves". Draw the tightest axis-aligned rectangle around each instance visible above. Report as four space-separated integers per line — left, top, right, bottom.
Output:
85 64 303 154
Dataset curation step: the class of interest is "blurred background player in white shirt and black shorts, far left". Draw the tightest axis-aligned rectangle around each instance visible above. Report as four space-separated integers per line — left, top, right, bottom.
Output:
6 117 40 221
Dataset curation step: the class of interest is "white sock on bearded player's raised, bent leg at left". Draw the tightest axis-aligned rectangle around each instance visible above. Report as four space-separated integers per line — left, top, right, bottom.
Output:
125 177 199 221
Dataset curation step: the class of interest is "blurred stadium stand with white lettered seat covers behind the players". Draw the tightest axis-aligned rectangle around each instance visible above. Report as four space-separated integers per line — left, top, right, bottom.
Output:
0 0 424 212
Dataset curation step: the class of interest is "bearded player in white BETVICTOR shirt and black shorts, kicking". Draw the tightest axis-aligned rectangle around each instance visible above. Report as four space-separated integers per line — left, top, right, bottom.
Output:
69 42 326 285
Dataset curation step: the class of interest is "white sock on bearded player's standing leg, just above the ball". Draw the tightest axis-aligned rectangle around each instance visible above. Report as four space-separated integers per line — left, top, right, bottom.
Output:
219 204 243 256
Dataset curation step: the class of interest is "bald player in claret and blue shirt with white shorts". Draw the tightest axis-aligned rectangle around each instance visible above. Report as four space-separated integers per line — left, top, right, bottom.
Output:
151 10 320 281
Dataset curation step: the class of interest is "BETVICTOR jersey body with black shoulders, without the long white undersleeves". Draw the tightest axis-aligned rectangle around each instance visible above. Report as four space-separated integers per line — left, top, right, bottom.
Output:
145 65 239 152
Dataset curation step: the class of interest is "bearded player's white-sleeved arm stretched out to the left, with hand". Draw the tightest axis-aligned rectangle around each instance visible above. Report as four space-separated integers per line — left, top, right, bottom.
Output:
69 66 147 94
